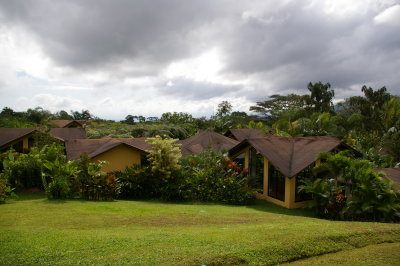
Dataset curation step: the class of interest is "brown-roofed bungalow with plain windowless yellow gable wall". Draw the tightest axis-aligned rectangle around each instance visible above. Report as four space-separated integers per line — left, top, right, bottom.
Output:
65 138 151 172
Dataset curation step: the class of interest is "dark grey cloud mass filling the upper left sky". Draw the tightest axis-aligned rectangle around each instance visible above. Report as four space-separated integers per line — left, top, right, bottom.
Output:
0 0 231 69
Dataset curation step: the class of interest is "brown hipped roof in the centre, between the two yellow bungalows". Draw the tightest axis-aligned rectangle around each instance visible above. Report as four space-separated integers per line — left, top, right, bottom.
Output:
178 130 239 156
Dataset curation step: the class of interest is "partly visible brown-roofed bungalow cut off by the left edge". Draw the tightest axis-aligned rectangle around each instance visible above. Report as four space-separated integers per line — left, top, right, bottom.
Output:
0 128 36 152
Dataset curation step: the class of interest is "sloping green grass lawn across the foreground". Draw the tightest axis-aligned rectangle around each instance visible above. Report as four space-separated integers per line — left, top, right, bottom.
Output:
0 194 400 265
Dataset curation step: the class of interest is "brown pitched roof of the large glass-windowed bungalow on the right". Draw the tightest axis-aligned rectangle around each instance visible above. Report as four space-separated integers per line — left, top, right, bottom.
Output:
229 135 342 177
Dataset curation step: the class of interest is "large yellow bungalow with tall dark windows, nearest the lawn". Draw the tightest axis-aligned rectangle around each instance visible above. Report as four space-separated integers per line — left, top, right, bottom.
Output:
229 135 348 208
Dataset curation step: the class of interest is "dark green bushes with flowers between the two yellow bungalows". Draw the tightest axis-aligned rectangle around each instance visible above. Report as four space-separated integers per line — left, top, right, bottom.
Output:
115 150 255 204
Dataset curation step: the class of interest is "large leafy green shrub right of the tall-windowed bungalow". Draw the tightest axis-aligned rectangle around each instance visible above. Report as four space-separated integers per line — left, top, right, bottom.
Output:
300 152 400 221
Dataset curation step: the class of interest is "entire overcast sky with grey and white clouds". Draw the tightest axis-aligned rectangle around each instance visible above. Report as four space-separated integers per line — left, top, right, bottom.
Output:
0 0 400 120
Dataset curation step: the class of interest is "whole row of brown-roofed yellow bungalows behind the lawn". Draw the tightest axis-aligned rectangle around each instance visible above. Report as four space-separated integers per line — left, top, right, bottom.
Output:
0 121 400 208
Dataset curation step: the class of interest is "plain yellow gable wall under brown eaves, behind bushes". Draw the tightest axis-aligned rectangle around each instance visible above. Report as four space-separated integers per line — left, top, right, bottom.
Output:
91 145 142 172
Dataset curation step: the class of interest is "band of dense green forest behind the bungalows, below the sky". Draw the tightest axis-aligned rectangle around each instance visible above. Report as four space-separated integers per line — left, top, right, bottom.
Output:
0 82 400 167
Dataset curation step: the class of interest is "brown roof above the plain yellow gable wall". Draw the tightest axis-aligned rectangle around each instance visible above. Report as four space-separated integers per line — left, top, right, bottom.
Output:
65 138 151 160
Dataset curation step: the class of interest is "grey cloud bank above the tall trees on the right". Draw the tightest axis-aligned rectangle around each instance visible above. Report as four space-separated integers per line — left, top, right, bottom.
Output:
222 1 400 100
